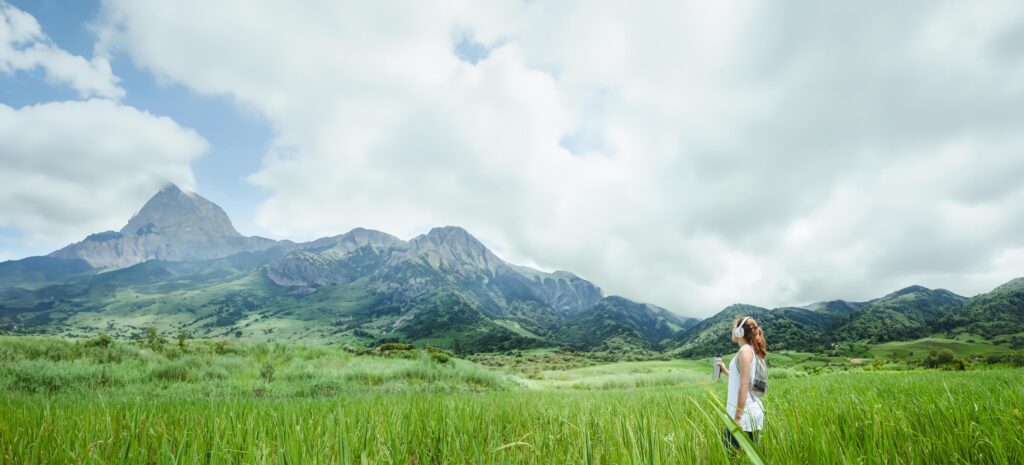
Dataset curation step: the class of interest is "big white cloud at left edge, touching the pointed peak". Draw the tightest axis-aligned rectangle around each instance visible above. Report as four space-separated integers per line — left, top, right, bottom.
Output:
0 99 207 248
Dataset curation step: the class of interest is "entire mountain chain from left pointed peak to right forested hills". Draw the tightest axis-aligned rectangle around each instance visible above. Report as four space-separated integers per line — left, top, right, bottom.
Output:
0 184 1024 356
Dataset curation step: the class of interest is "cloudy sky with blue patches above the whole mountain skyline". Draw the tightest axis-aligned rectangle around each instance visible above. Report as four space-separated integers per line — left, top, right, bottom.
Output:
0 0 1024 316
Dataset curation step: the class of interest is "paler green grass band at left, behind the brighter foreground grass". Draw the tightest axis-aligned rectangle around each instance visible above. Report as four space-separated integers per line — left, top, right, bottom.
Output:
0 338 519 397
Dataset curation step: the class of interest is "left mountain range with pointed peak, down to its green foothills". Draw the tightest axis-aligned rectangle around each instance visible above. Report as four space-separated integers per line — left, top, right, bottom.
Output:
0 184 693 350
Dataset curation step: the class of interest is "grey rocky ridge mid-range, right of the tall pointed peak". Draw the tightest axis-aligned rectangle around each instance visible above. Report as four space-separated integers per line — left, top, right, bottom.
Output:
264 226 603 316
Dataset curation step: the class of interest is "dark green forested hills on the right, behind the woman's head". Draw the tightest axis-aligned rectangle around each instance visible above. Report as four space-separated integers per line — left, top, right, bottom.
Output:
669 280 1024 356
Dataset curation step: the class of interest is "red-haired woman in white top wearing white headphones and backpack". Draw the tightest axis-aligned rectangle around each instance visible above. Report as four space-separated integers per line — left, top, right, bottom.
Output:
718 316 768 449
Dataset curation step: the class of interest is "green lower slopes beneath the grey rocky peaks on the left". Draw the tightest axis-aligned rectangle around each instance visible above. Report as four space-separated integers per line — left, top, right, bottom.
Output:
0 247 693 351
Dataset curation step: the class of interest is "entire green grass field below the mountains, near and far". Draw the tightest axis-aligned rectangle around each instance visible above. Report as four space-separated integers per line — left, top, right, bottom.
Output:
0 338 1024 465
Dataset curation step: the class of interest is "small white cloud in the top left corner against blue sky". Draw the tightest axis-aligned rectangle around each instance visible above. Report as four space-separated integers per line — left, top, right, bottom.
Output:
0 1 125 99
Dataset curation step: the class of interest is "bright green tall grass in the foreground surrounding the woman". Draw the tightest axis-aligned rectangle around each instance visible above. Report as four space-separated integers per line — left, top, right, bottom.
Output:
0 367 1024 465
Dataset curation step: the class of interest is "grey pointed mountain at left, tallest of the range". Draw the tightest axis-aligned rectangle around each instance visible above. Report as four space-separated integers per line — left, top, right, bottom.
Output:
49 184 287 269
